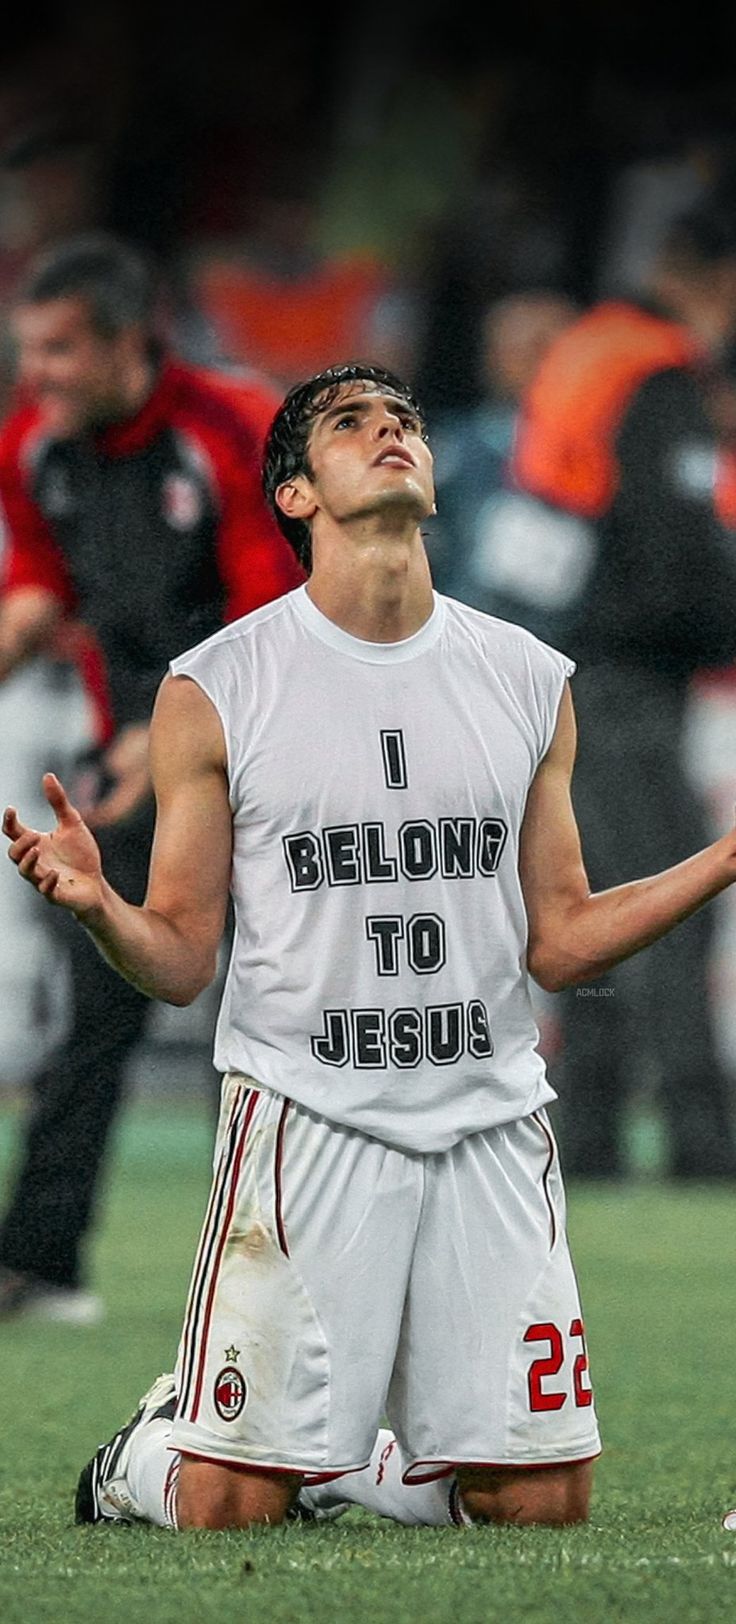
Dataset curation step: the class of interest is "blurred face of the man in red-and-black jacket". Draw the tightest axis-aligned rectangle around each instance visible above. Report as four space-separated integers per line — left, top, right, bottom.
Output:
13 296 125 438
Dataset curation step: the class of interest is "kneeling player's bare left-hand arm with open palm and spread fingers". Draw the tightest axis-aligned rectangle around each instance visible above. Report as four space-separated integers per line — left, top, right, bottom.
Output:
3 677 232 1004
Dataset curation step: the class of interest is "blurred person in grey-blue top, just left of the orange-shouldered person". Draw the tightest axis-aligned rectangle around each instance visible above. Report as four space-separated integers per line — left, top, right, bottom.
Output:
427 287 577 607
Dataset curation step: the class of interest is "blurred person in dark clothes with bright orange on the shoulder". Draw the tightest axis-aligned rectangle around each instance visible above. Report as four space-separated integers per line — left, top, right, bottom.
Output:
471 198 736 1177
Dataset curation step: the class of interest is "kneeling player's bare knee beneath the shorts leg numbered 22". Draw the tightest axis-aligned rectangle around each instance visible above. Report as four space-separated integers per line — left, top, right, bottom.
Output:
458 1462 593 1527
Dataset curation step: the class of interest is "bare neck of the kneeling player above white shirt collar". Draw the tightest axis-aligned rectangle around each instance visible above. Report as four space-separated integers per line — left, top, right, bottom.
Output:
307 536 434 643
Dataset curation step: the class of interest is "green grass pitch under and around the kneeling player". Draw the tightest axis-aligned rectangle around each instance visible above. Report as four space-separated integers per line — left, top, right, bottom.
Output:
0 1103 736 1624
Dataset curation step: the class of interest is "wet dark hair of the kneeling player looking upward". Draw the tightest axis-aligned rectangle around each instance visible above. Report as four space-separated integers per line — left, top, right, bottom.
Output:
263 361 426 573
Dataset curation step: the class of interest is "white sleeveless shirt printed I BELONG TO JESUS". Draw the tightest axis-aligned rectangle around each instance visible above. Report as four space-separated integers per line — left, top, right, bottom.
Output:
171 586 575 1151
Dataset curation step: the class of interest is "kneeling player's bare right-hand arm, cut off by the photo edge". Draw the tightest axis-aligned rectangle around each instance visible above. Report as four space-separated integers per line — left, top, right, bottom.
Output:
520 684 736 992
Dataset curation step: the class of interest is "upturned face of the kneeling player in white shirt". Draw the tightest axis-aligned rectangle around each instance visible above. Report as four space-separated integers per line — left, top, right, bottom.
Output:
300 378 434 523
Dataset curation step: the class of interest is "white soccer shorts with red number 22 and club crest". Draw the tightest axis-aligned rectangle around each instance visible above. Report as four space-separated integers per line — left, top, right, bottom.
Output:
171 1075 600 1481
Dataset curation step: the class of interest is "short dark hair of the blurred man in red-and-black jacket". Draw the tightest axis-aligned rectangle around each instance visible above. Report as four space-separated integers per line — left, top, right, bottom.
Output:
15 232 158 338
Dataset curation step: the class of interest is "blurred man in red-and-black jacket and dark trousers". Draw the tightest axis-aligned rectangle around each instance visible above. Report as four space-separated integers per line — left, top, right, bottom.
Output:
0 234 301 1324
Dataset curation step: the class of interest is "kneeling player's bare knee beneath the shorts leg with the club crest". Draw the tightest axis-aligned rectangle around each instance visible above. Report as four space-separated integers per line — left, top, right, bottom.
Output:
177 1460 301 1530
